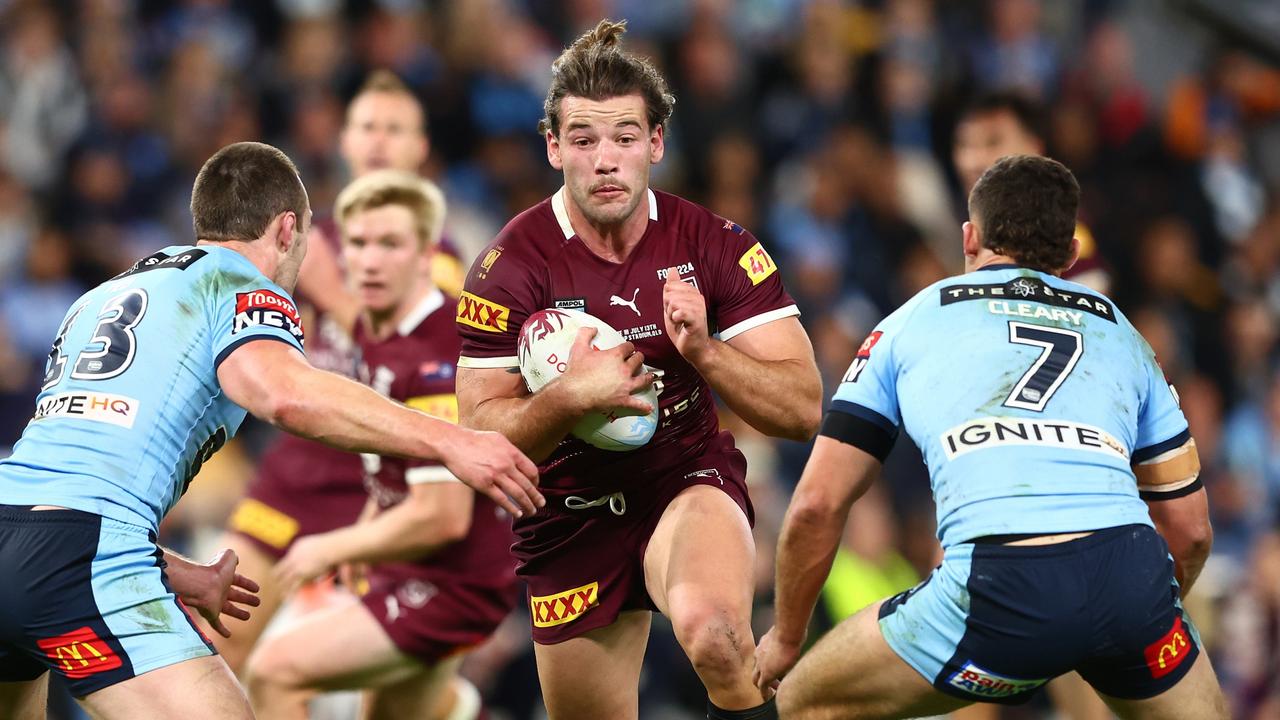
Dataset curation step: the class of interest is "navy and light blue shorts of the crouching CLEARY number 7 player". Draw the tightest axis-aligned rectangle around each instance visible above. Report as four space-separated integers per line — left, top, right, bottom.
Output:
879 525 1199 705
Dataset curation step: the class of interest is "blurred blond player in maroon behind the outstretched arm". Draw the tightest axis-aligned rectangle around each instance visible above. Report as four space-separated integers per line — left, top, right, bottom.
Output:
248 170 517 720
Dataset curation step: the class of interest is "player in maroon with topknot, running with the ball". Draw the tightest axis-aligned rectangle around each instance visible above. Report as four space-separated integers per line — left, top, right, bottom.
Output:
457 20 822 720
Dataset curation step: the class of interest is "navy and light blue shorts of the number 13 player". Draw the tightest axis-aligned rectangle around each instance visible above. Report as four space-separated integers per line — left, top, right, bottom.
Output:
0 505 214 697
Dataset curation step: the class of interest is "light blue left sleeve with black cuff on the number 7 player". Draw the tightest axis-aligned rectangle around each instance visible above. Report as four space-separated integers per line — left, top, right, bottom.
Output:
819 310 905 461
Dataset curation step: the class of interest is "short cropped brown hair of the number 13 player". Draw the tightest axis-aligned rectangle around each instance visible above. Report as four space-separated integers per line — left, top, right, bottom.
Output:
191 142 307 242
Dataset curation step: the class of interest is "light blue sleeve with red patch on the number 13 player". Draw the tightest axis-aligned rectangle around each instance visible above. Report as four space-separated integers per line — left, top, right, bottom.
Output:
206 260 303 368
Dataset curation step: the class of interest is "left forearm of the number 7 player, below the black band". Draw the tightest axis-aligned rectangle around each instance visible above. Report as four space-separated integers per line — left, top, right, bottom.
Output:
773 503 845 644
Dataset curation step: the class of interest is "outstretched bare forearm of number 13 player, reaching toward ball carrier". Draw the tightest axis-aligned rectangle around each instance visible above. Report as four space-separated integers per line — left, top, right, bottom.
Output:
264 369 457 460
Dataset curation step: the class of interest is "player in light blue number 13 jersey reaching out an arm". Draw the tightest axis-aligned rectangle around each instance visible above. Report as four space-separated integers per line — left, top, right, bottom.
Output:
0 142 541 720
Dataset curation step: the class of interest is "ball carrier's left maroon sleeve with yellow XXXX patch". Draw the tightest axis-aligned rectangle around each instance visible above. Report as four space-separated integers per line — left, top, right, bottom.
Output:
456 237 545 369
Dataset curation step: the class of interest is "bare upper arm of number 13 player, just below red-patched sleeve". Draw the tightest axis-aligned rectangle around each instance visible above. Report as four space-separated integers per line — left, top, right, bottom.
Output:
218 336 314 420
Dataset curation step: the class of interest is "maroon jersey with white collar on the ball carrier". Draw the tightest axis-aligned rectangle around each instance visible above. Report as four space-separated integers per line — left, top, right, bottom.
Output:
457 188 800 488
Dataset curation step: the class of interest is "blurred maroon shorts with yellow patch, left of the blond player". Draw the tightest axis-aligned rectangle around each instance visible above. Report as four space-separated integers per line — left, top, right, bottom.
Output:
227 437 369 560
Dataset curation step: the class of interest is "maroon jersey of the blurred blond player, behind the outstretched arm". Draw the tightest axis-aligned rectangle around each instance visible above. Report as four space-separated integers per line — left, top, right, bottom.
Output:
356 290 515 587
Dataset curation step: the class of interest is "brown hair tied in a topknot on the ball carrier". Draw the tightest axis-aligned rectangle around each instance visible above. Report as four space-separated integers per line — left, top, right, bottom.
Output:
538 19 676 136
